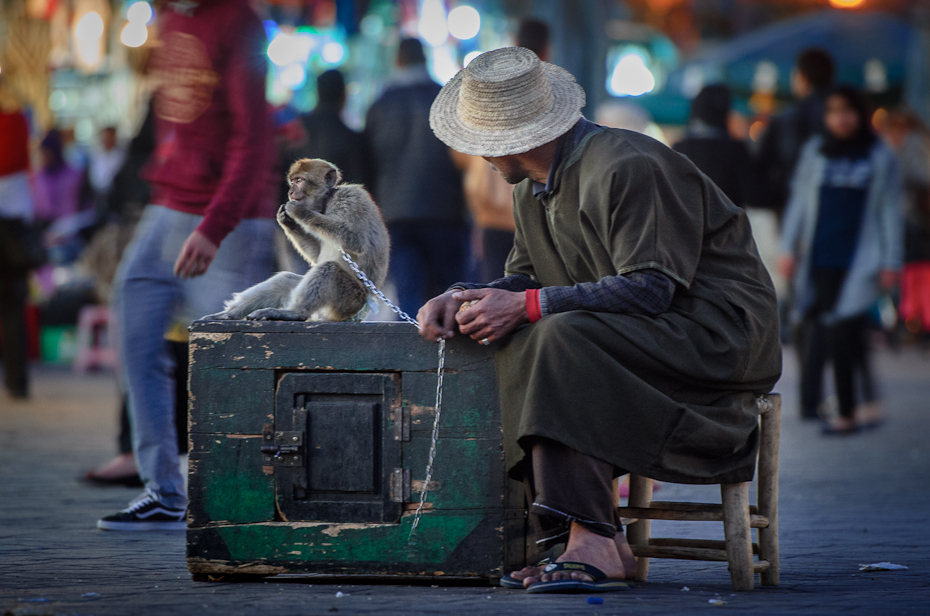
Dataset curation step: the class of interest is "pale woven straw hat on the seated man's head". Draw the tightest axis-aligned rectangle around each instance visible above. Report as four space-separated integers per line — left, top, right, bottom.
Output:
429 47 584 156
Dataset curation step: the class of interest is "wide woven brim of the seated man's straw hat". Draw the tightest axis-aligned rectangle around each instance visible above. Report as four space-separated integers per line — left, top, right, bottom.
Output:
429 62 585 157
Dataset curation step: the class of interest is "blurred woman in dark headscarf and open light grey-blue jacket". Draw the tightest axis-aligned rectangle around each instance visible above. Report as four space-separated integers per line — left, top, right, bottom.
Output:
780 86 904 434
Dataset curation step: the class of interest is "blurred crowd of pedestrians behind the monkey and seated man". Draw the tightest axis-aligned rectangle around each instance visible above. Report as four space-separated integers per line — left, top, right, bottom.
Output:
0 3 930 502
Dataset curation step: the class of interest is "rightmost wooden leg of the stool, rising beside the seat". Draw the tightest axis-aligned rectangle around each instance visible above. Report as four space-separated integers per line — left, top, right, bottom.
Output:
758 394 781 586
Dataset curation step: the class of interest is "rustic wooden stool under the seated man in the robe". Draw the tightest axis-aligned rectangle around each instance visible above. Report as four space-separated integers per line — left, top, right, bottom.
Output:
619 394 781 590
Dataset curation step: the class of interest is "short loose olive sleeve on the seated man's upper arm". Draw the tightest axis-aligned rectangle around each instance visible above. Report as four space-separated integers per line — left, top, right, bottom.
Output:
581 146 704 288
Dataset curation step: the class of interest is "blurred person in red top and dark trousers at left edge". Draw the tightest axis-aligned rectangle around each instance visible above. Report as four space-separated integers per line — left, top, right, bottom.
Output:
0 95 40 398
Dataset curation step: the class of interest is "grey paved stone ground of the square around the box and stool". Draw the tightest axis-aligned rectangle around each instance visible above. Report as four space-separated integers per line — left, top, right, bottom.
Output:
0 351 930 616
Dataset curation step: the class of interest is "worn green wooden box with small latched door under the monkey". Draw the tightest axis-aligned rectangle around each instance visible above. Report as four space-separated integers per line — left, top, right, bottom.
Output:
187 321 527 579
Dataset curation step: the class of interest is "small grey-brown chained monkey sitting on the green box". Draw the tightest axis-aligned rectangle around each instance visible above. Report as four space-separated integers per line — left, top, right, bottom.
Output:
203 158 390 321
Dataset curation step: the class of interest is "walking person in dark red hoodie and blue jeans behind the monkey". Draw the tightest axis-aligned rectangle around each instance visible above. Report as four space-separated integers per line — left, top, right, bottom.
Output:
97 0 277 530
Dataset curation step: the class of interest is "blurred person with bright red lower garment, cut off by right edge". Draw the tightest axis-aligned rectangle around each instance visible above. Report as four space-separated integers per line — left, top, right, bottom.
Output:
885 109 930 339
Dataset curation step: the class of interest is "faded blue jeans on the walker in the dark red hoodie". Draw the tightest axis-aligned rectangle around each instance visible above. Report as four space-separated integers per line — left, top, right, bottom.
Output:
113 205 275 508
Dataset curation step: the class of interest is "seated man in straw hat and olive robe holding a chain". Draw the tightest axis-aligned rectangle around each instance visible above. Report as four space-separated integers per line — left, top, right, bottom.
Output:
419 47 781 593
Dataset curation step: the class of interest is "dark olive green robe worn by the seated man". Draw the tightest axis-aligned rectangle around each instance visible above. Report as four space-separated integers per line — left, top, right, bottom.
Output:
497 129 781 483
